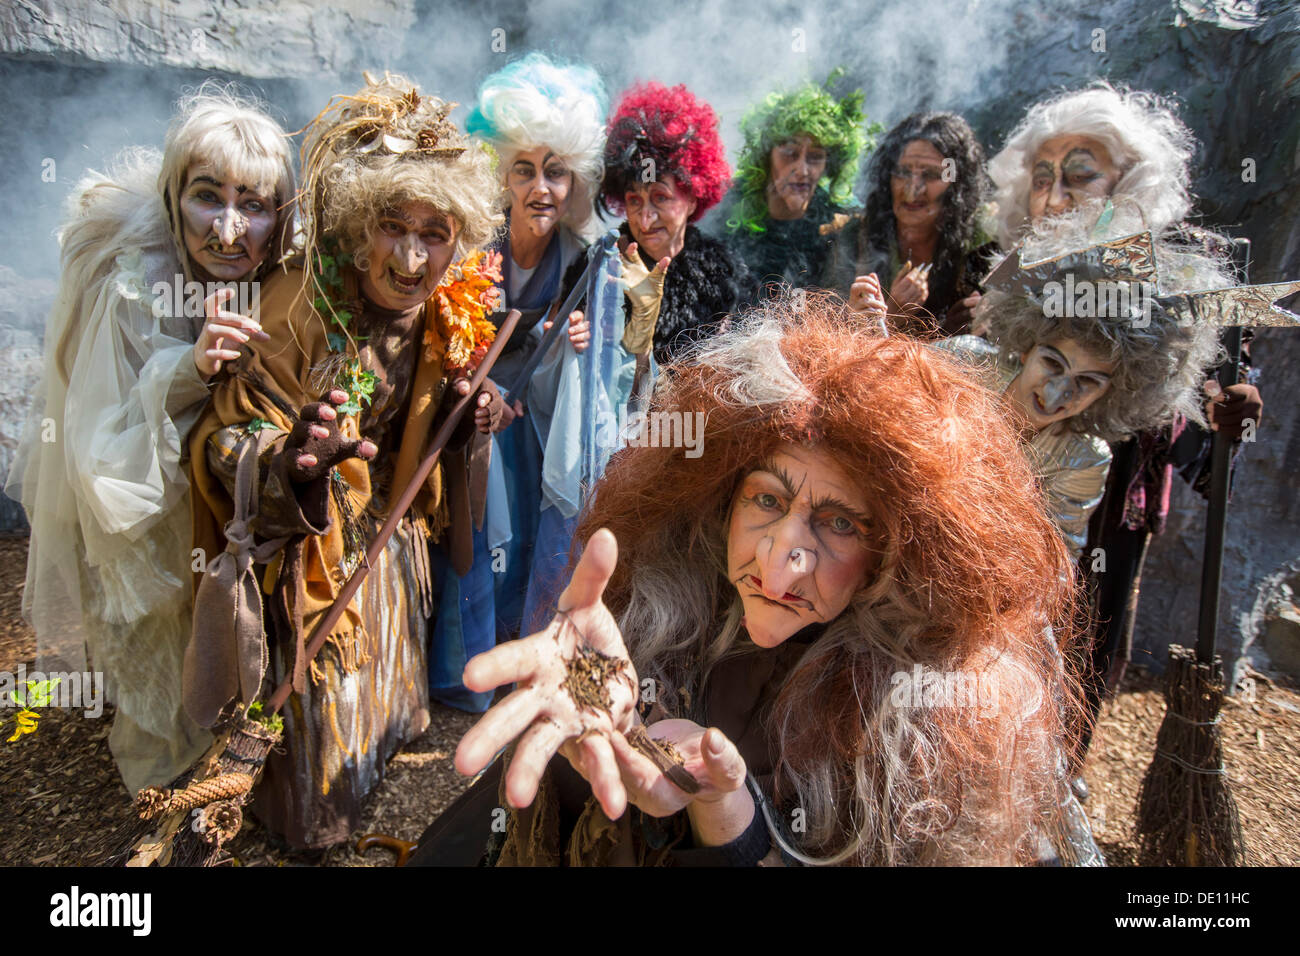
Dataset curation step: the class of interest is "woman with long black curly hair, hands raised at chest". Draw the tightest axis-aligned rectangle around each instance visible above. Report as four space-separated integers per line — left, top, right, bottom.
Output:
826 113 989 336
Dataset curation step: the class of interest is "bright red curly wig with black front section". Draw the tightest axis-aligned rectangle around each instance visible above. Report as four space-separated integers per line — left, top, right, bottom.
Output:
601 83 731 222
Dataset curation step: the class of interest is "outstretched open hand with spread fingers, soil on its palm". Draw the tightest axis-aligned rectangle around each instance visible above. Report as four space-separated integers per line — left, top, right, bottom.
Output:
455 529 637 819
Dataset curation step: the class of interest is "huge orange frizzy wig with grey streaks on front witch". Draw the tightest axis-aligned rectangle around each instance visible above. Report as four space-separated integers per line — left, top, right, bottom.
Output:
577 295 1078 864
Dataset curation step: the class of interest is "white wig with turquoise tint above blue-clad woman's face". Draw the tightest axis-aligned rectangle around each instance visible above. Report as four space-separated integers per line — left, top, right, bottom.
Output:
465 53 608 232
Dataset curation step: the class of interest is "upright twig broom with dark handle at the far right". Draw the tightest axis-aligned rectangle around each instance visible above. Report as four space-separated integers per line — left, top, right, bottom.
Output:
1138 239 1251 866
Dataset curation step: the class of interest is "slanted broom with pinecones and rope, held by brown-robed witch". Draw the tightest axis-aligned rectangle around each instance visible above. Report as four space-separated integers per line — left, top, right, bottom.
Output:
101 310 519 866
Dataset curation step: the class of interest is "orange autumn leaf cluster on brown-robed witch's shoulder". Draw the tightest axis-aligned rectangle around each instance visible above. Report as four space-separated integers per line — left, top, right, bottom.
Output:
424 250 502 375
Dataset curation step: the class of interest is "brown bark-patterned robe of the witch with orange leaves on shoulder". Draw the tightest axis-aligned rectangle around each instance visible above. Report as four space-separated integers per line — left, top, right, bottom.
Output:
186 268 462 847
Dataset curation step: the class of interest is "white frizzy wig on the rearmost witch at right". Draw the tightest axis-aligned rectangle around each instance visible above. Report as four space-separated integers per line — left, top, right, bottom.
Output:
988 82 1196 248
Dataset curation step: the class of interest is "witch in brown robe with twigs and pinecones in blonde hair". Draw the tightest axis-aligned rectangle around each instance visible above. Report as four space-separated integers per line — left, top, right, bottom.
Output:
186 74 502 848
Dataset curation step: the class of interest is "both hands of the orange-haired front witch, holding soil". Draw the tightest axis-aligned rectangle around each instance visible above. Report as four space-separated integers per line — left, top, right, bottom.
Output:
456 529 754 845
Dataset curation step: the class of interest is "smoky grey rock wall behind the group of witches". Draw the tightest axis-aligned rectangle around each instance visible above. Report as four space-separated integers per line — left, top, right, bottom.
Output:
0 0 1300 674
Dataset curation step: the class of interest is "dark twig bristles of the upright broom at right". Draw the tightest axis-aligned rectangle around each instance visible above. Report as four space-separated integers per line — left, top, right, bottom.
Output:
1136 644 1245 866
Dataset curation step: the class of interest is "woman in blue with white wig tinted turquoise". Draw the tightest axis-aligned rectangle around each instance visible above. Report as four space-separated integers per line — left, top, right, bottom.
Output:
430 53 607 711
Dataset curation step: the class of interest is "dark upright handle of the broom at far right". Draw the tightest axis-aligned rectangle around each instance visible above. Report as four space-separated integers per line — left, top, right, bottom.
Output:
1196 239 1251 663
